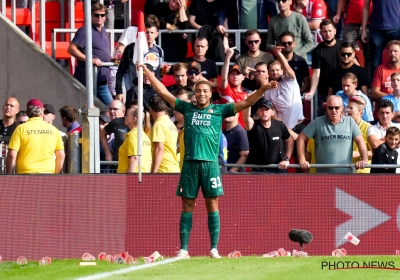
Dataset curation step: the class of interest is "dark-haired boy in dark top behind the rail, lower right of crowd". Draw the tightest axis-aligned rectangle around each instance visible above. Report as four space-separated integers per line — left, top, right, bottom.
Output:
370 126 400 173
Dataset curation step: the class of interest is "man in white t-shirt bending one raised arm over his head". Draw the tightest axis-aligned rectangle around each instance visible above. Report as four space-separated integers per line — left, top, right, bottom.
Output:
264 50 304 139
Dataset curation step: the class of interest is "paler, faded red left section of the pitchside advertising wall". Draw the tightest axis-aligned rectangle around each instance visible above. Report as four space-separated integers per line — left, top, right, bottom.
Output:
0 175 126 260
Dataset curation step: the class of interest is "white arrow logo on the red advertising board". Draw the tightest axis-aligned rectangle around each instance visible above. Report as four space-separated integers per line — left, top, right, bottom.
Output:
336 188 391 245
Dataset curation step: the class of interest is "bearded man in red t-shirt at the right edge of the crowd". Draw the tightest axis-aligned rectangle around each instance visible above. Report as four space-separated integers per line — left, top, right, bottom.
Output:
371 40 400 116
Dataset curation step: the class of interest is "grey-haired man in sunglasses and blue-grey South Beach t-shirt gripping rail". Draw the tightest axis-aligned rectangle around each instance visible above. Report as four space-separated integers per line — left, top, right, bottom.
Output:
296 95 368 174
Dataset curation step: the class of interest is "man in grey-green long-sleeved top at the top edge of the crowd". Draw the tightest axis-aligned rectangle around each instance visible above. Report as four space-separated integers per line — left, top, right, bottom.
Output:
267 0 314 59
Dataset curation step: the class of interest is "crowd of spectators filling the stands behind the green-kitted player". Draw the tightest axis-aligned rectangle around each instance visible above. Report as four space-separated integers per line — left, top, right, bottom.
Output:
0 0 400 173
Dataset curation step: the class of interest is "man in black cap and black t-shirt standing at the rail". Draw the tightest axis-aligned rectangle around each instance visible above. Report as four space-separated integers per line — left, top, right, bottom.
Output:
243 100 294 173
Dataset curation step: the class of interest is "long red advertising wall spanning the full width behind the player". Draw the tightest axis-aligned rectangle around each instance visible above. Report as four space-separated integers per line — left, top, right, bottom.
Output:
0 174 400 260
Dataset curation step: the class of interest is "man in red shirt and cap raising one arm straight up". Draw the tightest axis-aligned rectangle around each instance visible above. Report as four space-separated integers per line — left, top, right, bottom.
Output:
219 48 247 127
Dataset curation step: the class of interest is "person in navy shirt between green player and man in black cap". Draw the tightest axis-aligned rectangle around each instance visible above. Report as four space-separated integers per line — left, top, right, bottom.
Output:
222 114 249 172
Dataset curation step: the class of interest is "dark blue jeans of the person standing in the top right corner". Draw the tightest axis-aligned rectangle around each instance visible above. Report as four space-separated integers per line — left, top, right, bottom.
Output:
369 28 400 81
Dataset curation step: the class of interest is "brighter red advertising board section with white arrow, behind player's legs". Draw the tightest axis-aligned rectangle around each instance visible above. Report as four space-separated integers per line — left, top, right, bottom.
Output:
126 175 400 255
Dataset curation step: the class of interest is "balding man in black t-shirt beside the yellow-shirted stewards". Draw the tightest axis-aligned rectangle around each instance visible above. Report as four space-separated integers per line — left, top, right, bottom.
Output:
100 100 129 161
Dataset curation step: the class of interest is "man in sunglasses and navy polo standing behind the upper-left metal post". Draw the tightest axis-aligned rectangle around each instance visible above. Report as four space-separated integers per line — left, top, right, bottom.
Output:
68 3 113 107
